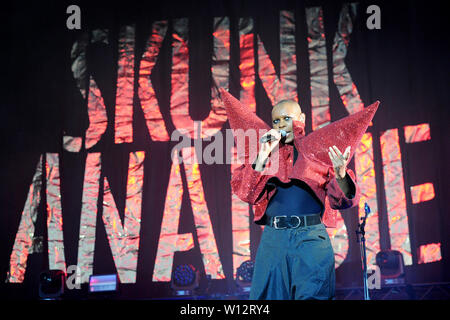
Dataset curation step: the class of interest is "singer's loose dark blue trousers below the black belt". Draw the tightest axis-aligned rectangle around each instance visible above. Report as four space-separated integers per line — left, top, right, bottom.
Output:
250 223 336 300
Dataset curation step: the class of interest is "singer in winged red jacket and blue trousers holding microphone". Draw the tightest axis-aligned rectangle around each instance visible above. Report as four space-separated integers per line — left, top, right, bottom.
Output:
221 90 379 300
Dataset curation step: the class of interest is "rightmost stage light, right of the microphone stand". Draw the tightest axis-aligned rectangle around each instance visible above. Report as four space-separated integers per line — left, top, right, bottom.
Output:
375 250 406 287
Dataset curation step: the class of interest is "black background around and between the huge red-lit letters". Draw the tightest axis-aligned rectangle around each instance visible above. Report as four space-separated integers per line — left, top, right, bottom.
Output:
0 0 450 298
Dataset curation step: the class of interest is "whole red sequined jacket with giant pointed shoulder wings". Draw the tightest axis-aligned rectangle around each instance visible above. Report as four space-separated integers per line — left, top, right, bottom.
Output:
221 89 379 228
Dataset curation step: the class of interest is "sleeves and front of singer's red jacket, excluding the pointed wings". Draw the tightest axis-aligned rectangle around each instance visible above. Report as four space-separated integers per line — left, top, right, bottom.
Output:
231 139 360 228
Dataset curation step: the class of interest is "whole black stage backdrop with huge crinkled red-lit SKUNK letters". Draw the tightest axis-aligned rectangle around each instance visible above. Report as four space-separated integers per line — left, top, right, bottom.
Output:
0 1 450 298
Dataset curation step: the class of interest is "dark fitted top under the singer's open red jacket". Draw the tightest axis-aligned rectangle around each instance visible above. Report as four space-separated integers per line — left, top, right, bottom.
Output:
266 147 323 216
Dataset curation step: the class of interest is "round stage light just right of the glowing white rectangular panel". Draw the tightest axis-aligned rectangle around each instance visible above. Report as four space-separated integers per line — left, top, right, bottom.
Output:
171 264 199 296
